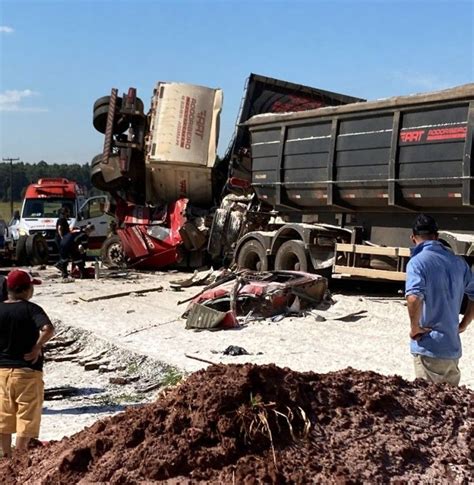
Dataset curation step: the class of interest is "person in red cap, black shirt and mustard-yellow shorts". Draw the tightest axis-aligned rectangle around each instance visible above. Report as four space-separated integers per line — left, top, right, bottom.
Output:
0 269 54 456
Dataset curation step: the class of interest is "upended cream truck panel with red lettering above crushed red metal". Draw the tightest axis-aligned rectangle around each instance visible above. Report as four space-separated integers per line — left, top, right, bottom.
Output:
146 83 222 204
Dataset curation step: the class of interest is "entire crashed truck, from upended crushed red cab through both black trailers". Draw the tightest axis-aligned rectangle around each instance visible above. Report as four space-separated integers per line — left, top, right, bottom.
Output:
91 74 474 281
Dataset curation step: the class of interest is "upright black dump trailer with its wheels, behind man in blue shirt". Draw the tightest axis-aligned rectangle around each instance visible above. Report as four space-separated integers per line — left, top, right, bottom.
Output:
235 84 474 280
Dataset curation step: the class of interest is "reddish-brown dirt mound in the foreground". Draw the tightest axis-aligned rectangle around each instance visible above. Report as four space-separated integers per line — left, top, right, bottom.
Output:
0 364 474 485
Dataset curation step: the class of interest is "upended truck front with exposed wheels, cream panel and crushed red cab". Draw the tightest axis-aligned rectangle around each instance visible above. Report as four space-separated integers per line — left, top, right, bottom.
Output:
91 83 222 268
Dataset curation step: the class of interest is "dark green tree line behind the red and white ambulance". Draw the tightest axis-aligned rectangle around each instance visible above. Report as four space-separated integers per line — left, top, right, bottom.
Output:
0 160 96 202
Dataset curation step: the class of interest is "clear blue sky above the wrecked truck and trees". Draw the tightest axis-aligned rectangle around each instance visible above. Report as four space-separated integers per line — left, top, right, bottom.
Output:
0 0 474 163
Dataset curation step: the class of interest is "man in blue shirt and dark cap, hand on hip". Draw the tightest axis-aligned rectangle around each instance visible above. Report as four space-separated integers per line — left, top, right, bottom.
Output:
405 214 474 386
